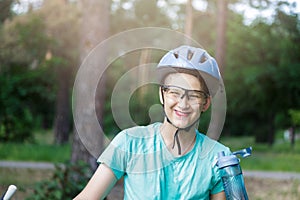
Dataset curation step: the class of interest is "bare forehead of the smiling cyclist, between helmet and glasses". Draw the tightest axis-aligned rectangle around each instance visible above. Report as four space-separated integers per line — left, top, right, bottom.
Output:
164 73 202 90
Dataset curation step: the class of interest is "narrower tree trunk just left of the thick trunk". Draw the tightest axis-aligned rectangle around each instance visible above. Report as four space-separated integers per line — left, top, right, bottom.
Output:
49 0 78 144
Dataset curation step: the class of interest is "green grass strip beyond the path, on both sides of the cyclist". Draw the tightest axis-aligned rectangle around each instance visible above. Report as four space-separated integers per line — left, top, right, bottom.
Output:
0 131 300 172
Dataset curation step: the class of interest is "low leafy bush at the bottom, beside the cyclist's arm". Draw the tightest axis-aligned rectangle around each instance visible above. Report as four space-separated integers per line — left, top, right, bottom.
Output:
27 162 92 200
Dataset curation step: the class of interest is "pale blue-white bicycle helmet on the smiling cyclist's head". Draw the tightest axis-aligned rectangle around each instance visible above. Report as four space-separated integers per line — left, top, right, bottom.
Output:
157 46 221 96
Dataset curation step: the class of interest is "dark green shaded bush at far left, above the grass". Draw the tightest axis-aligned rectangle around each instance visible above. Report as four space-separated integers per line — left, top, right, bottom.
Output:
0 66 54 141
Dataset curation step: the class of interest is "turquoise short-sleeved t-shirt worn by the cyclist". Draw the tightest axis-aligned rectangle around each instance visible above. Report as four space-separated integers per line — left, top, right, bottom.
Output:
98 123 230 200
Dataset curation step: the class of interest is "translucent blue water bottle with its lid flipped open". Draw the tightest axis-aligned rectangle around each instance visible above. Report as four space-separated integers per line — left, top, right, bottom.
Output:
217 147 252 200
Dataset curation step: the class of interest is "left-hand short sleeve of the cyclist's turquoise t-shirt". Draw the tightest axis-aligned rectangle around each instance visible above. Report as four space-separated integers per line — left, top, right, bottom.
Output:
97 131 127 179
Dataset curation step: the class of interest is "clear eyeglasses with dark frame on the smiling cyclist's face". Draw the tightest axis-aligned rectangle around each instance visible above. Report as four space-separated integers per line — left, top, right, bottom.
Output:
161 85 208 104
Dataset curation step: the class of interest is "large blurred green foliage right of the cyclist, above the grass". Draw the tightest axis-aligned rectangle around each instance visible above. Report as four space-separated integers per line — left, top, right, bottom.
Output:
224 3 300 144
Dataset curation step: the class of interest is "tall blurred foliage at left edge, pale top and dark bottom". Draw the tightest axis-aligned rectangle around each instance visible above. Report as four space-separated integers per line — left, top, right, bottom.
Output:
0 7 54 142
